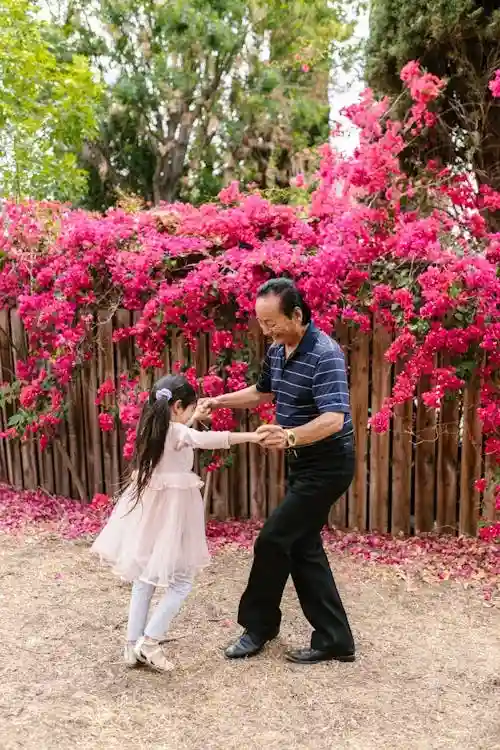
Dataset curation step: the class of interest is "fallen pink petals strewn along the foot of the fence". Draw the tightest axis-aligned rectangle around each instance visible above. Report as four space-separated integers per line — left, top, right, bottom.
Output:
0 485 500 601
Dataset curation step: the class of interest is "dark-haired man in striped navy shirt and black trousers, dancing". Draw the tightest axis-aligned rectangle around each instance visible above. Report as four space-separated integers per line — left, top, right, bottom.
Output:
201 278 354 664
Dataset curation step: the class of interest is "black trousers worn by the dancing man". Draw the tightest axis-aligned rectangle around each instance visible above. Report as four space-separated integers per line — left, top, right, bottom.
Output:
238 437 355 653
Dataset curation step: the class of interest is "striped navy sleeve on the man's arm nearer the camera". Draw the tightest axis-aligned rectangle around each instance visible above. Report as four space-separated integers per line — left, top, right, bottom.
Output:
312 346 350 414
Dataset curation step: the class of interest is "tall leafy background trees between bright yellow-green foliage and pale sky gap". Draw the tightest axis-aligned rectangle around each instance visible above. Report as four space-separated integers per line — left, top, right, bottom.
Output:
49 0 358 208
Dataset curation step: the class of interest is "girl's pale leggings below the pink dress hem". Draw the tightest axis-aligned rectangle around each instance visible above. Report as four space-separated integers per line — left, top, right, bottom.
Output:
127 574 193 643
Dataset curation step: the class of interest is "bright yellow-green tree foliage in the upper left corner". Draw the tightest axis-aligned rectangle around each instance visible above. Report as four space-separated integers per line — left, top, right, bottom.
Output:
0 0 100 200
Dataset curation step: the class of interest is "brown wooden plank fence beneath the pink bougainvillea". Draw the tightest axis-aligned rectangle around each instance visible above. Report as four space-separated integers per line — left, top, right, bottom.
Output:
0 310 495 534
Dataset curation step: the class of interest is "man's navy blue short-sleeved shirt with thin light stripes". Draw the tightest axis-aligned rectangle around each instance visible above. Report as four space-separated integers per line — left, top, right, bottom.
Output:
257 323 353 442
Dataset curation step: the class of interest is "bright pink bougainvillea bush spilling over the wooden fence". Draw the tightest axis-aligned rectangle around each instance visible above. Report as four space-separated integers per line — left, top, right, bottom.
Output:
0 62 500 538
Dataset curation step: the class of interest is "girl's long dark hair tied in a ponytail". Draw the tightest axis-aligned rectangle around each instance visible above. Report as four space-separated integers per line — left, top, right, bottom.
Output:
132 375 196 508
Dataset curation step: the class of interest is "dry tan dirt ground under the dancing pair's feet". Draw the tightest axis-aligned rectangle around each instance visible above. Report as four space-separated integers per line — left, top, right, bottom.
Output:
0 535 500 750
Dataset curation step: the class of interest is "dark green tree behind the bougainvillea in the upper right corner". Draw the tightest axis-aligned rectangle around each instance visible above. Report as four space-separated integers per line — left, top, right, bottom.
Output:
366 0 500 210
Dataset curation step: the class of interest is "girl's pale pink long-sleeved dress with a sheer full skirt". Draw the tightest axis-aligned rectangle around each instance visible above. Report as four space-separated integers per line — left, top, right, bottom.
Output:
92 422 230 586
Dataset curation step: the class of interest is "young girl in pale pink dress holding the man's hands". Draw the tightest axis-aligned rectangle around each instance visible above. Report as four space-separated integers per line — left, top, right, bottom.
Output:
92 375 259 671
